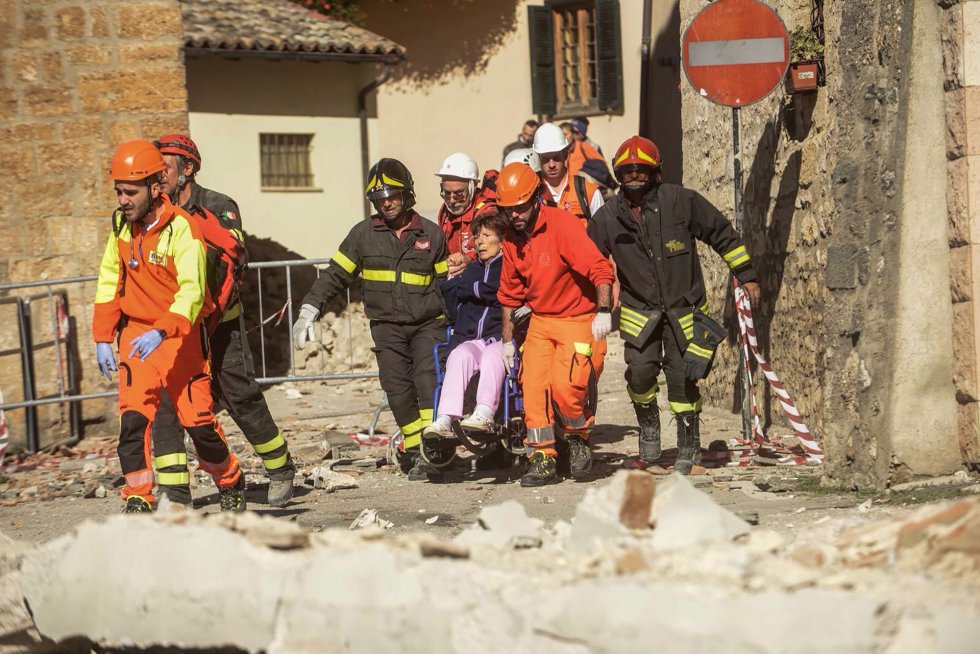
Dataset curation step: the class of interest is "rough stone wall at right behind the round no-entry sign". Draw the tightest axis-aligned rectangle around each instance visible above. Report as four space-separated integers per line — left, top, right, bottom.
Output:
681 0 958 486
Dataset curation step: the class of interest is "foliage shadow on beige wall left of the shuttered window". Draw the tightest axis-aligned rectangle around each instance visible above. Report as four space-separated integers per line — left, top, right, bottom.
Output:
363 0 521 86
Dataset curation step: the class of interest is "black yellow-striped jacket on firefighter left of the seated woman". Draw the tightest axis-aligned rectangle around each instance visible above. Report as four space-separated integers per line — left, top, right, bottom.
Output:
303 211 449 324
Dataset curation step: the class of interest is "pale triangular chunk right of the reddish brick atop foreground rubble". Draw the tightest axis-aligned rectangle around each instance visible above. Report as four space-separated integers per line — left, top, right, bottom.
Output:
651 474 750 550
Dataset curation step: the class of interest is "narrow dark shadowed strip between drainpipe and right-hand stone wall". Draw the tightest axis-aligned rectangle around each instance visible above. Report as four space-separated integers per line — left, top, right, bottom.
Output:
645 0 687 184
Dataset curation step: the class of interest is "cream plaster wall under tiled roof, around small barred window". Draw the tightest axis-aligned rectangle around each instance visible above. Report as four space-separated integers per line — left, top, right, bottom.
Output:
187 59 377 259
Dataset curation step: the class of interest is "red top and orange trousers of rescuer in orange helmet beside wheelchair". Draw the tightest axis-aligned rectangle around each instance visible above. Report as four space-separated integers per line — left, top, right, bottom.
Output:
497 205 613 457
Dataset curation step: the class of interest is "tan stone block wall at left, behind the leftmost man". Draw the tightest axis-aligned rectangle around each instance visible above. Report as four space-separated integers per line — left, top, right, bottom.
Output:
0 0 187 446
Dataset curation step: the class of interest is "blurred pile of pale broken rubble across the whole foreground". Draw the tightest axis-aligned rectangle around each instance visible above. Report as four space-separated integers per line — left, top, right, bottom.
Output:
0 471 980 653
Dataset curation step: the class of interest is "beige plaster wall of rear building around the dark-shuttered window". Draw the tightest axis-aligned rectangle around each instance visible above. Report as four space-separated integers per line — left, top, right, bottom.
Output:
363 0 679 217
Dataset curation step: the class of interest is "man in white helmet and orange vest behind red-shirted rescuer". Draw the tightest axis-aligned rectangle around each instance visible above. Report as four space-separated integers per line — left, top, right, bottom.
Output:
532 123 603 225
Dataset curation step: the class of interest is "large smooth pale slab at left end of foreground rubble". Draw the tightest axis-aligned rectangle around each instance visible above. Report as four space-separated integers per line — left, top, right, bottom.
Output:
19 516 291 651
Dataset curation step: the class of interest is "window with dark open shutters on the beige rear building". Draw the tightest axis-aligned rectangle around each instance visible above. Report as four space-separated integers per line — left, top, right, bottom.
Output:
527 0 623 117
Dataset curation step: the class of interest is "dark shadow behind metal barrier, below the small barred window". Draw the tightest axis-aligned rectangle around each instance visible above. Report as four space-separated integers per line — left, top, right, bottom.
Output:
242 234 361 377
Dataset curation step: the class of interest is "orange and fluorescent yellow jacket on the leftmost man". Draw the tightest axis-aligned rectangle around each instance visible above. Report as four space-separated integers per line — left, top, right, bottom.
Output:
92 196 206 343
